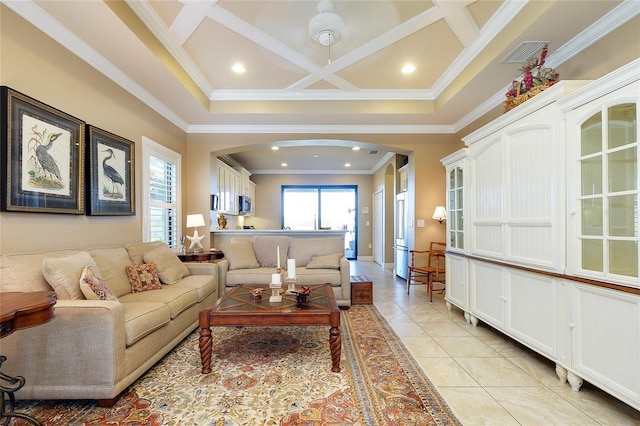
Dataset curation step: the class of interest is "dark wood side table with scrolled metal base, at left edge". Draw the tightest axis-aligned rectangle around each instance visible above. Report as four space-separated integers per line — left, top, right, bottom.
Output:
0 291 56 426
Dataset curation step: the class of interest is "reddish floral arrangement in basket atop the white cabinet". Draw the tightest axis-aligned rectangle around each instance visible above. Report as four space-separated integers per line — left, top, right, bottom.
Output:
504 44 560 112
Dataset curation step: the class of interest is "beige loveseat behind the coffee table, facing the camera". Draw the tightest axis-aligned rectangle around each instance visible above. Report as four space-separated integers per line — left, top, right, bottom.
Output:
218 235 351 307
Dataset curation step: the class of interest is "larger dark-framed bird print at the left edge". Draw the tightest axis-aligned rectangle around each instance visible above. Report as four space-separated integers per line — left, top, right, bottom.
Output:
0 86 85 214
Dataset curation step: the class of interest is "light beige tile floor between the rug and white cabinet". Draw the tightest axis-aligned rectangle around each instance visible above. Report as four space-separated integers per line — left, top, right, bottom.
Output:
351 261 640 426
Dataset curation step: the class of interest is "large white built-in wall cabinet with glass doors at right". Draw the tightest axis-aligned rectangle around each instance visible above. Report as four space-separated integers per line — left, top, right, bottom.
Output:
442 59 640 409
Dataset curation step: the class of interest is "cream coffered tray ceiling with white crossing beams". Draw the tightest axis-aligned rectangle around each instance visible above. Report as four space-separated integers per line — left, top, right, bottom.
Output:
3 0 639 170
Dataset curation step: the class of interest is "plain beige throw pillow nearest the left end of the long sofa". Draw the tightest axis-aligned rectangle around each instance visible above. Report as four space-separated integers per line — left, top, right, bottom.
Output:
42 251 99 300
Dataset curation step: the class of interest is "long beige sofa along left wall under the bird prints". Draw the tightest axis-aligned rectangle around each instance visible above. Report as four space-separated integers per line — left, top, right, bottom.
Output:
0 243 219 406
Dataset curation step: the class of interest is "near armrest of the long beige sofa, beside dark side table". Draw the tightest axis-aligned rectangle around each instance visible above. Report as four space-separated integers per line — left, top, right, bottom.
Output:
2 300 126 398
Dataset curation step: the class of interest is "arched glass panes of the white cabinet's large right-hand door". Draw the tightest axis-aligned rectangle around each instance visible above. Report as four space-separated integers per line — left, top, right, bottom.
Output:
580 103 639 277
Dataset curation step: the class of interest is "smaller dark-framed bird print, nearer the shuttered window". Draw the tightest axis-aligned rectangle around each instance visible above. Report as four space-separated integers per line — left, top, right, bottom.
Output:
87 126 136 216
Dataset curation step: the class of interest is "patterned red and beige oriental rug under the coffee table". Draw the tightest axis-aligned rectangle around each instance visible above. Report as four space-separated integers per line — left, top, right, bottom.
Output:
13 305 460 426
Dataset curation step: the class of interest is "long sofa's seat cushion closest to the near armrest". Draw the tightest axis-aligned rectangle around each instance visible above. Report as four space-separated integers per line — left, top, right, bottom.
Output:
123 302 171 346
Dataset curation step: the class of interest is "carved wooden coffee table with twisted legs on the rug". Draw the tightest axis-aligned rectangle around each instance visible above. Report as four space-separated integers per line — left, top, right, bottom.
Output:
199 284 342 374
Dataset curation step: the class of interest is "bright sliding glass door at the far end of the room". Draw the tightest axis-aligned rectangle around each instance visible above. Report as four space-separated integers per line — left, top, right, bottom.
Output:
281 185 358 259
